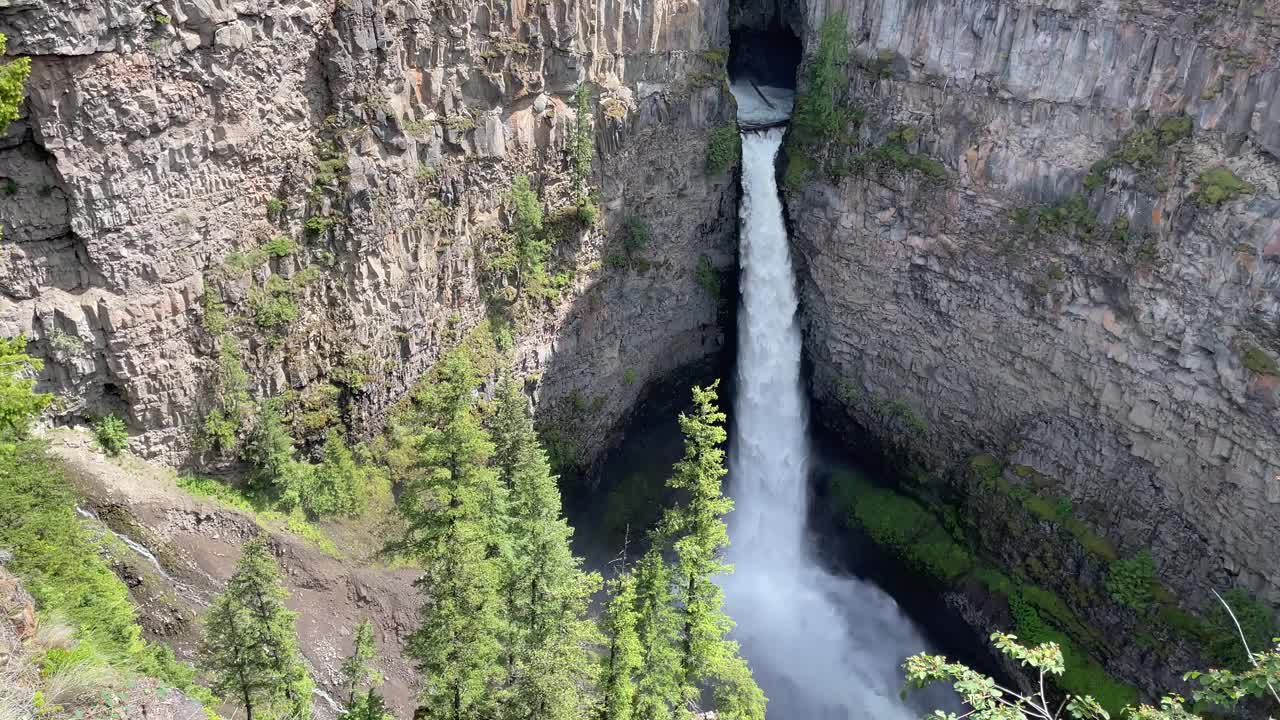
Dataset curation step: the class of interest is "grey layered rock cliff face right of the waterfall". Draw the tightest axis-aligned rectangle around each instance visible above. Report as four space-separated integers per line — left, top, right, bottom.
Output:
768 0 1280 696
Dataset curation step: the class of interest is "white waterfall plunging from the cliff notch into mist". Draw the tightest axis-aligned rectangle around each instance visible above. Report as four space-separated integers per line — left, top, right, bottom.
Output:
724 86 947 720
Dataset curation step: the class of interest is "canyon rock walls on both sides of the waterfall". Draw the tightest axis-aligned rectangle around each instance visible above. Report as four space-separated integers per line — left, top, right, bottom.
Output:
0 0 1280 702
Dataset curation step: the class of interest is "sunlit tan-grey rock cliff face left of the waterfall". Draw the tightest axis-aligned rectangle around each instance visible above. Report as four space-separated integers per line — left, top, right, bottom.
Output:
0 0 736 461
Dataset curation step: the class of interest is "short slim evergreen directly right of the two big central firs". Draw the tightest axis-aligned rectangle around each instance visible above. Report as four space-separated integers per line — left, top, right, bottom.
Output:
600 573 644 720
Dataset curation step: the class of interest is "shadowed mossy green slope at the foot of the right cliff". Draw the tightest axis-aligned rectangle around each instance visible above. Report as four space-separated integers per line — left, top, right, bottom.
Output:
828 455 1276 716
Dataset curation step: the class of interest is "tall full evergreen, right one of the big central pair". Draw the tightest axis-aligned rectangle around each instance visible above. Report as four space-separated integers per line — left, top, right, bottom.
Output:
490 377 600 720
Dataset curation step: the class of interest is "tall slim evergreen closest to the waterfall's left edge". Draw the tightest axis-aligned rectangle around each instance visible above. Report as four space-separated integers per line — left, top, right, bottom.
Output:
663 380 765 720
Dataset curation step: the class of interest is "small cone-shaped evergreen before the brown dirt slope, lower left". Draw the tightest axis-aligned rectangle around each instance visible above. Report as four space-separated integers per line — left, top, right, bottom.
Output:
201 537 312 720
